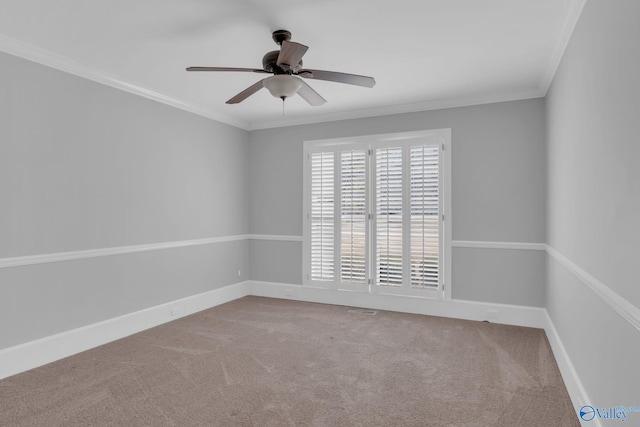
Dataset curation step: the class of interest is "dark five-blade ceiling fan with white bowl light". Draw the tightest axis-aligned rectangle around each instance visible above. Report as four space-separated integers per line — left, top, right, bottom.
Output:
187 30 376 106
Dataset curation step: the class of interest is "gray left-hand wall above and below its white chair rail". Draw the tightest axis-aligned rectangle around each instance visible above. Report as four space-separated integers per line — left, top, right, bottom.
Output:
0 54 249 349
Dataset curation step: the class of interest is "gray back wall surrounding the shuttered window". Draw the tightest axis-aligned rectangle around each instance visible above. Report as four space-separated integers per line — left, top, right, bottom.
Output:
249 99 546 306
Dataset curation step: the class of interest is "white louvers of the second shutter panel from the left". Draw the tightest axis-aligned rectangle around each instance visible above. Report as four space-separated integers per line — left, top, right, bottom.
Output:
340 150 367 285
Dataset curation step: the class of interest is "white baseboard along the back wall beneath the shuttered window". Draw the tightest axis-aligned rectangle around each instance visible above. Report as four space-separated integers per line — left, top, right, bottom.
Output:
247 281 547 329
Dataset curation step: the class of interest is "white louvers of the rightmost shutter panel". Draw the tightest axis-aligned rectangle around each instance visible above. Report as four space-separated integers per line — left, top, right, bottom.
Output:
410 145 440 289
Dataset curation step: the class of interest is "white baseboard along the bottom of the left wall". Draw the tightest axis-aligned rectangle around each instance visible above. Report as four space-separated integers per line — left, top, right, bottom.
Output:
0 282 247 379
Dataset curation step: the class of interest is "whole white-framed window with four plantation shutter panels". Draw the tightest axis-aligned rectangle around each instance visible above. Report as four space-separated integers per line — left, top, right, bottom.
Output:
303 129 451 297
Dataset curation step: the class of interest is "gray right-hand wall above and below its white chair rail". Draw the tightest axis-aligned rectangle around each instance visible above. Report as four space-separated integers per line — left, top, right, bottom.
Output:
546 0 640 407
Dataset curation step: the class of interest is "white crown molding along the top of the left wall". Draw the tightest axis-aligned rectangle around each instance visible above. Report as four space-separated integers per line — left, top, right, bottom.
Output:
0 34 249 130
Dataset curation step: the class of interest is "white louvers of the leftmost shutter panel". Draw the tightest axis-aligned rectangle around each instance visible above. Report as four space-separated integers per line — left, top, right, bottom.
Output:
310 152 335 280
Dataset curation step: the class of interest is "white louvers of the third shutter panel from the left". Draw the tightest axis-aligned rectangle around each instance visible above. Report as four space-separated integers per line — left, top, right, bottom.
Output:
375 147 403 286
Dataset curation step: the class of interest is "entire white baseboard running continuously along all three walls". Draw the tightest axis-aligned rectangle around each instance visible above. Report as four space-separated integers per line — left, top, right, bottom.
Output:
0 281 588 427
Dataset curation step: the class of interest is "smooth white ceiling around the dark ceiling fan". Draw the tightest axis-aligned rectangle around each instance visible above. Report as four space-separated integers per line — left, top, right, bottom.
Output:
0 0 585 129
